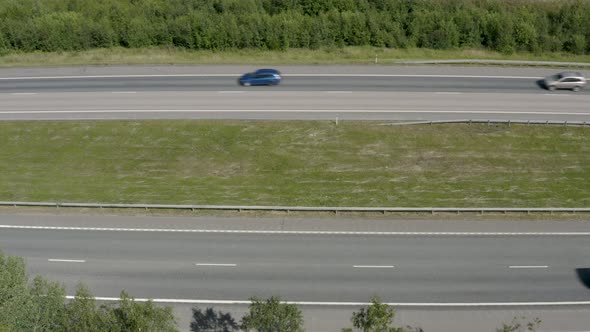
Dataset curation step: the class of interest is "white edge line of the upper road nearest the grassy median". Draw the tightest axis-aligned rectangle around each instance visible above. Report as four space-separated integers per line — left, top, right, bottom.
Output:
0 109 590 116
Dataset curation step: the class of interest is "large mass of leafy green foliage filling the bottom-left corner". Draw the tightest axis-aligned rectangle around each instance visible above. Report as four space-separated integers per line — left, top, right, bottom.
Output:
0 251 177 332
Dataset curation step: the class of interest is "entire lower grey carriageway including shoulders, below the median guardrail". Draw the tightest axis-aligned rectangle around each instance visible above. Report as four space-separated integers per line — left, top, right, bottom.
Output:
0 214 590 332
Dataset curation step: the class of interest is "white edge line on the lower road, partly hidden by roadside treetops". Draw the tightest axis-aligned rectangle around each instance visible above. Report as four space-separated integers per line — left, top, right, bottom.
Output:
66 295 590 307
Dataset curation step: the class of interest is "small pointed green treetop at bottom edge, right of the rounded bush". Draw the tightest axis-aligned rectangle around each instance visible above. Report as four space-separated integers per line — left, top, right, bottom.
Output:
350 296 403 332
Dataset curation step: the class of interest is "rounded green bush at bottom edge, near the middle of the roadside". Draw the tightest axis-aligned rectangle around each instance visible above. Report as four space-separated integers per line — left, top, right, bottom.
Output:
242 296 303 332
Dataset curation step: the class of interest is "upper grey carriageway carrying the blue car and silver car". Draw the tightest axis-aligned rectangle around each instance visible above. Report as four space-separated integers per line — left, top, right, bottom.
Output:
0 66 590 122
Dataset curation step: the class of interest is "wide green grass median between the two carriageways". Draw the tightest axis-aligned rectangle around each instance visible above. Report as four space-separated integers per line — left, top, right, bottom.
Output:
0 120 590 207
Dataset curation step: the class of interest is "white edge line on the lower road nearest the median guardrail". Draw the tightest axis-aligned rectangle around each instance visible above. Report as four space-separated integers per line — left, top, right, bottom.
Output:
0 225 590 236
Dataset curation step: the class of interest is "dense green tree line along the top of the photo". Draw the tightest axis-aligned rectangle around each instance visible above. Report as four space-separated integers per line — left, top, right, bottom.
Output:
0 0 590 54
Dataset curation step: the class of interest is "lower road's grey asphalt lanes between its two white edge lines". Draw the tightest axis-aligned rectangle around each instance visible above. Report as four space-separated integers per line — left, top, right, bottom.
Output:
0 223 590 303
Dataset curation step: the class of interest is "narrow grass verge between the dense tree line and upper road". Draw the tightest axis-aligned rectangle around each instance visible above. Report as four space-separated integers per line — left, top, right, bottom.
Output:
0 47 590 67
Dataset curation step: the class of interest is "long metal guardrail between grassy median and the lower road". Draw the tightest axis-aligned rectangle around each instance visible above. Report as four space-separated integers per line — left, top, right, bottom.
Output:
0 201 590 214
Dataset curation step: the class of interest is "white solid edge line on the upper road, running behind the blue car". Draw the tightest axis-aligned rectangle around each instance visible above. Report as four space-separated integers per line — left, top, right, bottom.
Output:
0 74 542 80
